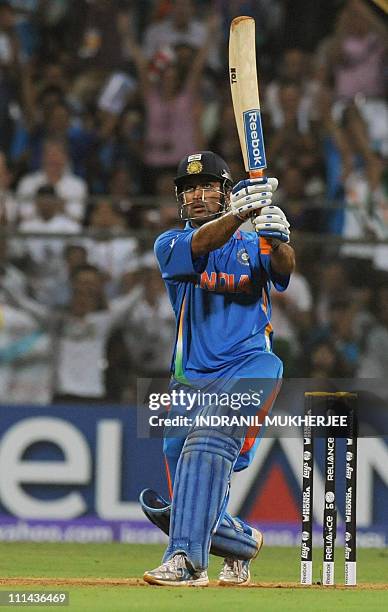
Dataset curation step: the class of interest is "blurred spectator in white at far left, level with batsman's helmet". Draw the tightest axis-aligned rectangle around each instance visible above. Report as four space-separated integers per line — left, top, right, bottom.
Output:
17 140 87 222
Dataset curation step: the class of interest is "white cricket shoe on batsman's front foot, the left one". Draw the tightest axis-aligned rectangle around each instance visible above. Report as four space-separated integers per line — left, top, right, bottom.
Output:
143 553 209 586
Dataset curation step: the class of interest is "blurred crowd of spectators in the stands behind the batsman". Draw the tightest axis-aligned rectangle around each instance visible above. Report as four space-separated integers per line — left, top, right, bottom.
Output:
0 0 388 404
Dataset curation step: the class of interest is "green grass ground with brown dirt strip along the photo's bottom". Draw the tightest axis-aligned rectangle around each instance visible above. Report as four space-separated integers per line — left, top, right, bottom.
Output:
0 542 388 612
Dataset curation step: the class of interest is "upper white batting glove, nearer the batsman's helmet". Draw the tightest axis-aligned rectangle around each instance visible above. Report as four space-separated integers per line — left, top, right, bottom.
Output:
230 177 278 221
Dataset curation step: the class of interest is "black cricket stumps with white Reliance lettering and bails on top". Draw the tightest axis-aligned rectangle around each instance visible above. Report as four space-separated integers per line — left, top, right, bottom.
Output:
300 392 358 586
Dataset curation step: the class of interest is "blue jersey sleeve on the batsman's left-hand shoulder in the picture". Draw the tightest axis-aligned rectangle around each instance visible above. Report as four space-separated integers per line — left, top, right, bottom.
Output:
154 229 209 279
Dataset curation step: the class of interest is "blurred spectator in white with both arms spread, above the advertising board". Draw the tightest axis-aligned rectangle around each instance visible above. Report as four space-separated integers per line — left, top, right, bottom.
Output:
2 265 139 403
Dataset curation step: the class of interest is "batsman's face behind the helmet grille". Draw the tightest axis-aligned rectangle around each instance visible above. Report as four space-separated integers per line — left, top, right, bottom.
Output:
179 177 225 225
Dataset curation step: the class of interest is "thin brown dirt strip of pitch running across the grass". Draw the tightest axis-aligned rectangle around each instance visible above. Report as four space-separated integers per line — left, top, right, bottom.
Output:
0 576 388 591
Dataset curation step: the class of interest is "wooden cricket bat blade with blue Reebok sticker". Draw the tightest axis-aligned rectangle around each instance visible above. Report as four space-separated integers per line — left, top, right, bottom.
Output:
229 16 267 177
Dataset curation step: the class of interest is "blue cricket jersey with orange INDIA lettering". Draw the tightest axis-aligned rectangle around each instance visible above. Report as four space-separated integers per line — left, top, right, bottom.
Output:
155 223 289 383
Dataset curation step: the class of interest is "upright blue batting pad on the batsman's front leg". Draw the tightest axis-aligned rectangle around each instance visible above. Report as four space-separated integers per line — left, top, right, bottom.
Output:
163 428 246 571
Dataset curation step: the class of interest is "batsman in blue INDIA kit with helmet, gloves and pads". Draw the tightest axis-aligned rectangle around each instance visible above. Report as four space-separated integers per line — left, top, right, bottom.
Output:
140 151 295 586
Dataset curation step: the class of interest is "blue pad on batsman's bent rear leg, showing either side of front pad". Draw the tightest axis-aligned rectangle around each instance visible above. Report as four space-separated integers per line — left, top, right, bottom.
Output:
139 489 257 561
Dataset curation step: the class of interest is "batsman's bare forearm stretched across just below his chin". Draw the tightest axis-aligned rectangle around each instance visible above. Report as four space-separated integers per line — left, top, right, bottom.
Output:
191 213 243 257
